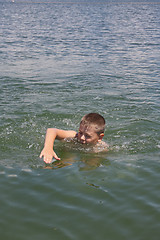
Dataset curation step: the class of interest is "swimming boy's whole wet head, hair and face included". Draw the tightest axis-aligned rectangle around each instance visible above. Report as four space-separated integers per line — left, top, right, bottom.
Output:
78 113 105 144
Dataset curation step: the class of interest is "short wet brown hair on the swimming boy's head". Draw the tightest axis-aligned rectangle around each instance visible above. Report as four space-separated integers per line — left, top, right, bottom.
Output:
80 113 105 134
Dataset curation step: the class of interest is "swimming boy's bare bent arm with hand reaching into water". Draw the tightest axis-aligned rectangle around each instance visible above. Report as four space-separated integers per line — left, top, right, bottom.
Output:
40 128 76 163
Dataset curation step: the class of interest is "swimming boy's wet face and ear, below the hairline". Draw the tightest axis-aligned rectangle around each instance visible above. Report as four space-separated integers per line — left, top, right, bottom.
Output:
77 124 104 144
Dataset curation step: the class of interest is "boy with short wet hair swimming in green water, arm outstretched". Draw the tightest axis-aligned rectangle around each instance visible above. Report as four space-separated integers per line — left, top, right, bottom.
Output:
40 113 108 163
